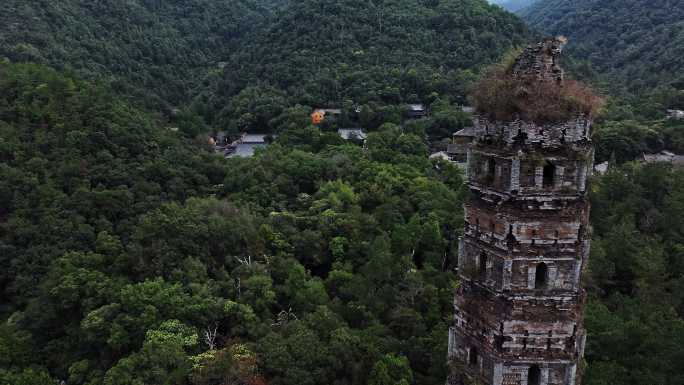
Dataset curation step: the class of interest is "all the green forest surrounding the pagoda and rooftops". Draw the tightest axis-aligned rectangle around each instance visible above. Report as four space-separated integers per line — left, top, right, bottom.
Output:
0 0 684 385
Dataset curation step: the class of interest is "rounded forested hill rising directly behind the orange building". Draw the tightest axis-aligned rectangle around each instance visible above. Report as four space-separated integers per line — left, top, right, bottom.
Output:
203 0 528 127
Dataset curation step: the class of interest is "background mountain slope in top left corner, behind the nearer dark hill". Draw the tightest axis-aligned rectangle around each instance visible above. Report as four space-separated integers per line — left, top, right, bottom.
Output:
0 0 275 109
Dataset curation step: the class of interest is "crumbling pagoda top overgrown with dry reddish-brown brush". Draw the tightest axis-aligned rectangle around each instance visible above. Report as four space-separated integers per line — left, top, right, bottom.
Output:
471 37 603 124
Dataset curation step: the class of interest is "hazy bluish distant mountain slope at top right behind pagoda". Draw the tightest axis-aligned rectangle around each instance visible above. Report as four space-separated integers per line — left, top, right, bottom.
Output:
522 0 684 91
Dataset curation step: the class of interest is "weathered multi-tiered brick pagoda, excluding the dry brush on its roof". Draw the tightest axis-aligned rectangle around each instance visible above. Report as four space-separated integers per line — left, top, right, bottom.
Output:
448 39 593 385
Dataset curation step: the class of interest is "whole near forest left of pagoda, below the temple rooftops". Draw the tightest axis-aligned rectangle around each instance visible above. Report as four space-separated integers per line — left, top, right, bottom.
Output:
0 64 462 385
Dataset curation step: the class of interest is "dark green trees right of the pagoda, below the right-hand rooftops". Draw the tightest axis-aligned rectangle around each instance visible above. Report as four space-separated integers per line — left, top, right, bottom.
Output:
585 164 684 385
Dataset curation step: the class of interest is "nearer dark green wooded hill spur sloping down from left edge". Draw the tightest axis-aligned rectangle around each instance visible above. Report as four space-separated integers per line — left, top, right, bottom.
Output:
0 65 225 303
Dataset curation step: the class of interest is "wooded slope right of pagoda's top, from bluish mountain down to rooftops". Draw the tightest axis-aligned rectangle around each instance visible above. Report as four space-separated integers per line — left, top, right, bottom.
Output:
522 0 684 163
